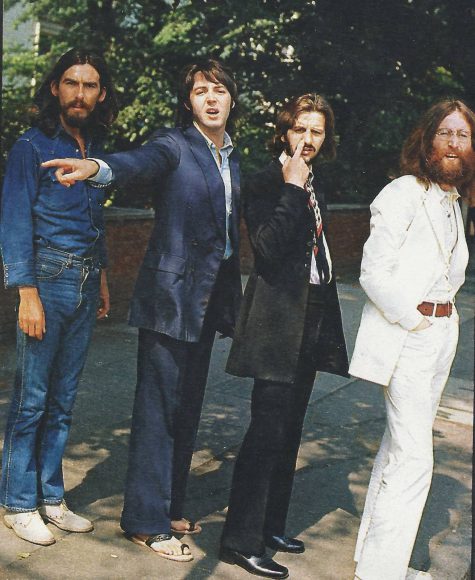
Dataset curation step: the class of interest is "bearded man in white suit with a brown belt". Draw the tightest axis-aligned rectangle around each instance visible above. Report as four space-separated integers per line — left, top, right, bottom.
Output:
350 100 475 580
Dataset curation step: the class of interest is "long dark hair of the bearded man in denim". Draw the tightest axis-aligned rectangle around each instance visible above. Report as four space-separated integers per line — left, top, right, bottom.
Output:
33 48 119 135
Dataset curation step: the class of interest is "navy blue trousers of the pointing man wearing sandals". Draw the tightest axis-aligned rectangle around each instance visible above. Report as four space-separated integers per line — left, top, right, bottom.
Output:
120 264 231 534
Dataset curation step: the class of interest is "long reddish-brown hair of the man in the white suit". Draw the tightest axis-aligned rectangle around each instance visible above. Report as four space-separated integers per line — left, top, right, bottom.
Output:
399 99 475 187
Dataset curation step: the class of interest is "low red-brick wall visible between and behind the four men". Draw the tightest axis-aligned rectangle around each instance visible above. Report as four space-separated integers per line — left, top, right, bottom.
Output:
0 205 369 341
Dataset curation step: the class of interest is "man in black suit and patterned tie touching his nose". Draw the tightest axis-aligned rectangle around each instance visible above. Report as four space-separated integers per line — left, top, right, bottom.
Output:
220 94 348 578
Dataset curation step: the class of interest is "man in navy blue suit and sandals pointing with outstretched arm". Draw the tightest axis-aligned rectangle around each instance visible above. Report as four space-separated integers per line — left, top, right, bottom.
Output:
47 60 241 561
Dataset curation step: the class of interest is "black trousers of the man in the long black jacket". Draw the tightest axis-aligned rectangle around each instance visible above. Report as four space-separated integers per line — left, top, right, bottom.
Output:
221 286 325 555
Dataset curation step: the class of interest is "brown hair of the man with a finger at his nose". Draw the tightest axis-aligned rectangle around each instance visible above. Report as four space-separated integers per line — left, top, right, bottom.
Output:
271 93 336 160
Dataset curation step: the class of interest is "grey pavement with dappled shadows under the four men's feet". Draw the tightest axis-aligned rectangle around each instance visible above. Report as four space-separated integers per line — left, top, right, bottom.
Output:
0 280 475 580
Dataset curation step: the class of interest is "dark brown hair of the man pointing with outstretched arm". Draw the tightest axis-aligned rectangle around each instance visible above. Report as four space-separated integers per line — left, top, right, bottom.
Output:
175 58 238 131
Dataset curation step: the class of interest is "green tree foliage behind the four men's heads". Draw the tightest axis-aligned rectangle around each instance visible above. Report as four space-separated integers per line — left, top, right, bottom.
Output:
4 0 475 204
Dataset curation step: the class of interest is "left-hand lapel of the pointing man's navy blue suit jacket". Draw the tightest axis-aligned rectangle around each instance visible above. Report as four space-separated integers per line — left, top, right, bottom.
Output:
184 126 226 237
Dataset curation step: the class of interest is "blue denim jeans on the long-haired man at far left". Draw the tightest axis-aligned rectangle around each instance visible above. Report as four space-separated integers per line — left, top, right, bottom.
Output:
0 248 100 511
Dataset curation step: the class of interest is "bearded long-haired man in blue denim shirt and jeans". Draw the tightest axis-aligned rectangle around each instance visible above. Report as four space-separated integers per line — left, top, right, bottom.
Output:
0 49 118 545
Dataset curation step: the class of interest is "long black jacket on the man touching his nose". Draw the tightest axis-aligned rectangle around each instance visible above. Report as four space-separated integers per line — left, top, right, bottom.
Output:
226 161 348 383
